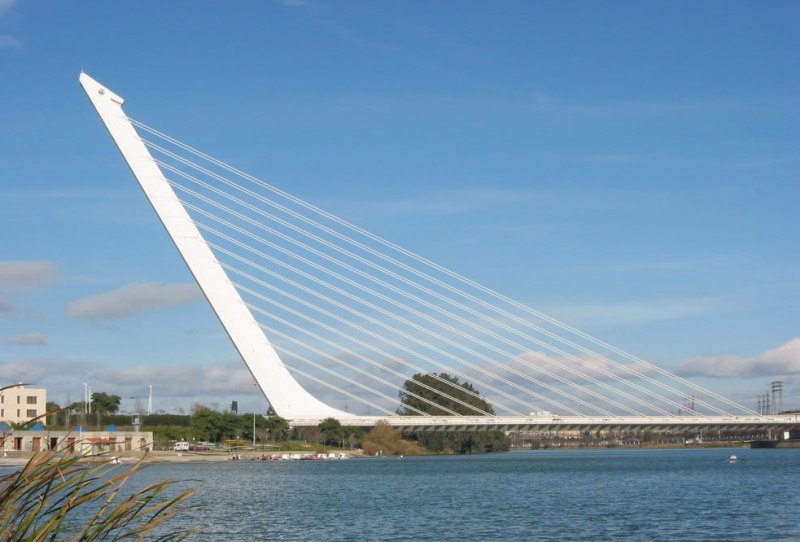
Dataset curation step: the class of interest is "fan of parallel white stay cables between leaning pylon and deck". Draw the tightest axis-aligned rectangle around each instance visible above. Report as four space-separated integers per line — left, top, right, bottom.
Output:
129 119 753 416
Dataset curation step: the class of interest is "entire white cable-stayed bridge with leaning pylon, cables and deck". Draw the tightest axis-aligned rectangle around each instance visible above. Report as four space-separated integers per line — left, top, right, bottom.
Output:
80 73 800 431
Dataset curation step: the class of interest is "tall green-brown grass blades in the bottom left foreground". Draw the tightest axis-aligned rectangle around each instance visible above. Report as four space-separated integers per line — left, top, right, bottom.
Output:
0 451 194 541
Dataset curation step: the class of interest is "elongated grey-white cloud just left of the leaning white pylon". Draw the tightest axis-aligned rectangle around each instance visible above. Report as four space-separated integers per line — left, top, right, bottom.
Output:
67 282 202 320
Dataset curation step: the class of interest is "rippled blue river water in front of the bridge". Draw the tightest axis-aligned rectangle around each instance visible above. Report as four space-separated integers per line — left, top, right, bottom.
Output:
143 448 800 541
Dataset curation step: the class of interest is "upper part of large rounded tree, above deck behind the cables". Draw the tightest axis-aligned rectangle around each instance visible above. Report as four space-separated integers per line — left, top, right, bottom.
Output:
397 373 494 416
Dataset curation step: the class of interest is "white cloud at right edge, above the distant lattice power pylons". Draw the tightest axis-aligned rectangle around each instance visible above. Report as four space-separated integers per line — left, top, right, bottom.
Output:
676 338 800 378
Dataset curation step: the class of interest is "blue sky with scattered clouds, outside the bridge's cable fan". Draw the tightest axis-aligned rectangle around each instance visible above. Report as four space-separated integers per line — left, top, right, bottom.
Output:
0 0 800 411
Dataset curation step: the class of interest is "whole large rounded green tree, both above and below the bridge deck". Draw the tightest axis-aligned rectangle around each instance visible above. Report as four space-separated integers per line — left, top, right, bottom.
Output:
397 373 511 454
